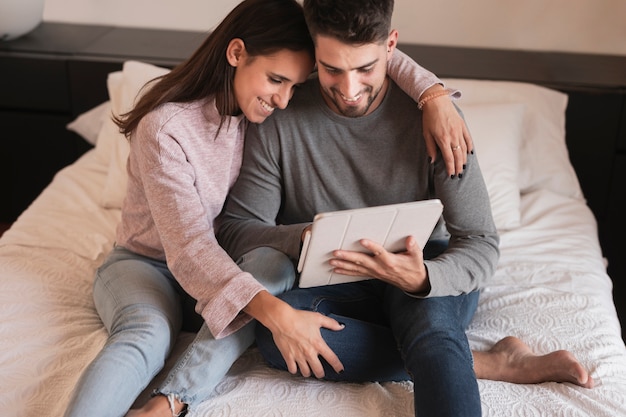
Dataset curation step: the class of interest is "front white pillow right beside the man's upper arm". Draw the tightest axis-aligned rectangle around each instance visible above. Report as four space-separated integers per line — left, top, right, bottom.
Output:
460 104 525 230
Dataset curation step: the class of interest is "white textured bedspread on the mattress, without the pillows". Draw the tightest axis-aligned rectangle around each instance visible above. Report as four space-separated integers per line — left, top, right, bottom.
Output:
0 147 626 417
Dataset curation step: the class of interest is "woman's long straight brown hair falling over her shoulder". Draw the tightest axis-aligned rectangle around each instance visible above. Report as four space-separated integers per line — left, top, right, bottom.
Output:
114 0 315 138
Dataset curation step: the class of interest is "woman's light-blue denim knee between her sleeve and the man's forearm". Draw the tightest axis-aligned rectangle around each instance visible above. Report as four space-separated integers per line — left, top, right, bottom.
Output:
237 247 296 295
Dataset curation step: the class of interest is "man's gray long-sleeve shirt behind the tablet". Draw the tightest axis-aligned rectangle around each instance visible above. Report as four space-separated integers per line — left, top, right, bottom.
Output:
216 79 499 296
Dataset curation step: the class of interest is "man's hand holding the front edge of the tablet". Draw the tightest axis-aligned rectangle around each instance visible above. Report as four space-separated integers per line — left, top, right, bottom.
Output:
330 236 430 294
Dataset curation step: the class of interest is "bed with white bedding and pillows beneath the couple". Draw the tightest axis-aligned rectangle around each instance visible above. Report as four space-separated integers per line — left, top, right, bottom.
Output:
0 56 626 417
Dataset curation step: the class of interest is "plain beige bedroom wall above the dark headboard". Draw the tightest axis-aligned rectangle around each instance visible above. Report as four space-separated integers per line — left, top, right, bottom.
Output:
44 0 626 55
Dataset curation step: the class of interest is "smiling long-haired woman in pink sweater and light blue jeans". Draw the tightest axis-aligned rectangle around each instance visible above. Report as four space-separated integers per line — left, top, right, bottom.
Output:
66 0 465 417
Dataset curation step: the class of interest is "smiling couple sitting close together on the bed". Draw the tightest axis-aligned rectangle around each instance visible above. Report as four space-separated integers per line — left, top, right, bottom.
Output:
66 0 593 417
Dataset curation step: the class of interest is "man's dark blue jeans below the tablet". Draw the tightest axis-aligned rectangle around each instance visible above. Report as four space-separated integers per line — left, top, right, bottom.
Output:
251 242 481 417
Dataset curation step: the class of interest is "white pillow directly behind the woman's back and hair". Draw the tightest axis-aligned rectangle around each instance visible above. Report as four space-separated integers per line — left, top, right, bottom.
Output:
96 61 170 208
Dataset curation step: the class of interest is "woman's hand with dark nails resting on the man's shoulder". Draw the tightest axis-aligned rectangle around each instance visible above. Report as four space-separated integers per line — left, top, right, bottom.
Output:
422 84 474 176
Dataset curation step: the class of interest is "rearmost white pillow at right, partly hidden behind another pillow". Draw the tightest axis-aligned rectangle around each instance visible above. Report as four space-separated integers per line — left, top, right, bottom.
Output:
444 79 583 199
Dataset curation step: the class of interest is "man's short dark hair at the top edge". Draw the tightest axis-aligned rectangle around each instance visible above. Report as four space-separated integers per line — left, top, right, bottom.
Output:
303 0 393 44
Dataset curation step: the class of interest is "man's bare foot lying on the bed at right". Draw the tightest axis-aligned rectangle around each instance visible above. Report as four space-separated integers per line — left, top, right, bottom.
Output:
473 336 593 388
